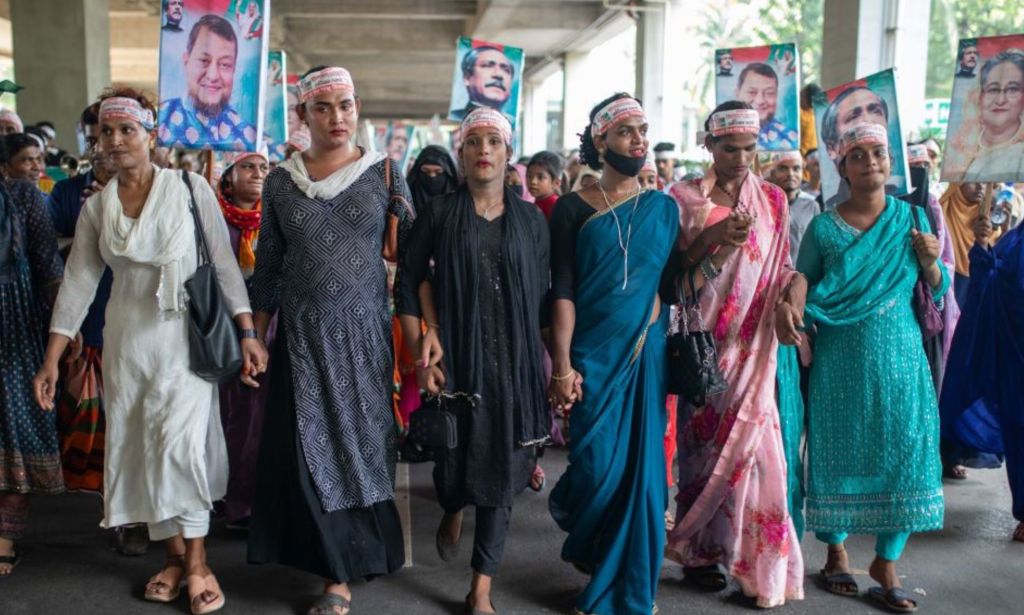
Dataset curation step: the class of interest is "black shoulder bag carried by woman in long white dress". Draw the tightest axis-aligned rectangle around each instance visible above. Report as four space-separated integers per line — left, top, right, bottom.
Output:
181 171 242 383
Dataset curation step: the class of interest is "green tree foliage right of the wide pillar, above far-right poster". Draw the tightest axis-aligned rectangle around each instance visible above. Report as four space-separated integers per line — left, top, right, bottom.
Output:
925 0 1024 98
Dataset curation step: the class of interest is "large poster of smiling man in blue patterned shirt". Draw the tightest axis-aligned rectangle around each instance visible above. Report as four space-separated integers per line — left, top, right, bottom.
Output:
158 0 270 151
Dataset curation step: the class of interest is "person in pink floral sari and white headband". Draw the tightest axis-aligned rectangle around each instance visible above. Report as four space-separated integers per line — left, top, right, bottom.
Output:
667 101 804 607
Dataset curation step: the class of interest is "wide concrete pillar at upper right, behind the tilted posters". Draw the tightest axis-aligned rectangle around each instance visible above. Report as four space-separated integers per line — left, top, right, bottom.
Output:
821 0 932 131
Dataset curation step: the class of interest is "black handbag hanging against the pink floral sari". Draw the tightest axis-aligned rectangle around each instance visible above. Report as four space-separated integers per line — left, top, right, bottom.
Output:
667 269 729 406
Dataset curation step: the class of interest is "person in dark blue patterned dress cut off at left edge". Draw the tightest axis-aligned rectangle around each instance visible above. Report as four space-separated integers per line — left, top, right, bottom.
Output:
0 153 63 577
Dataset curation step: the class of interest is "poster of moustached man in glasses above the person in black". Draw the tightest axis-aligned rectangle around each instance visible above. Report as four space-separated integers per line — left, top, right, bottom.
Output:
449 37 525 130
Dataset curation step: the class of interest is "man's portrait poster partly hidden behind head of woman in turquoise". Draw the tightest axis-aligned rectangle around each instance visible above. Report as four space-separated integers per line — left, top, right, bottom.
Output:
812 69 912 211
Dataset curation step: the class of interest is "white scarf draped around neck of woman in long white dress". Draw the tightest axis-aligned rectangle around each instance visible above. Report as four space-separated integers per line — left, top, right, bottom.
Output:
98 166 196 312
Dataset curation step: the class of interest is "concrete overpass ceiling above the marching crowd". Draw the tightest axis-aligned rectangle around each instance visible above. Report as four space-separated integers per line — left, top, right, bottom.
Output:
99 0 617 119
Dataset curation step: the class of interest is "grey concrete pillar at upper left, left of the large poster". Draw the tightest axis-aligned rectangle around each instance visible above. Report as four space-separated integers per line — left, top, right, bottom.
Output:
10 0 111 152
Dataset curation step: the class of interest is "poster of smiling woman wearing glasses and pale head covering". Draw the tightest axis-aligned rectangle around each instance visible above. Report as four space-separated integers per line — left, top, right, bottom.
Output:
942 34 1024 182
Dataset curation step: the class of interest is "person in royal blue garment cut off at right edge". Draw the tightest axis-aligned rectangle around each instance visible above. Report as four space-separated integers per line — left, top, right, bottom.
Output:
940 218 1024 542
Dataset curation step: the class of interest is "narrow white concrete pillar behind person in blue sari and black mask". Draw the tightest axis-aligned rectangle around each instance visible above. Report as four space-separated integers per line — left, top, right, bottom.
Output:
636 0 679 147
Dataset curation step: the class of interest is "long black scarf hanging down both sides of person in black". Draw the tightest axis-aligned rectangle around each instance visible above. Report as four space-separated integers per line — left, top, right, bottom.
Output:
433 183 551 446
